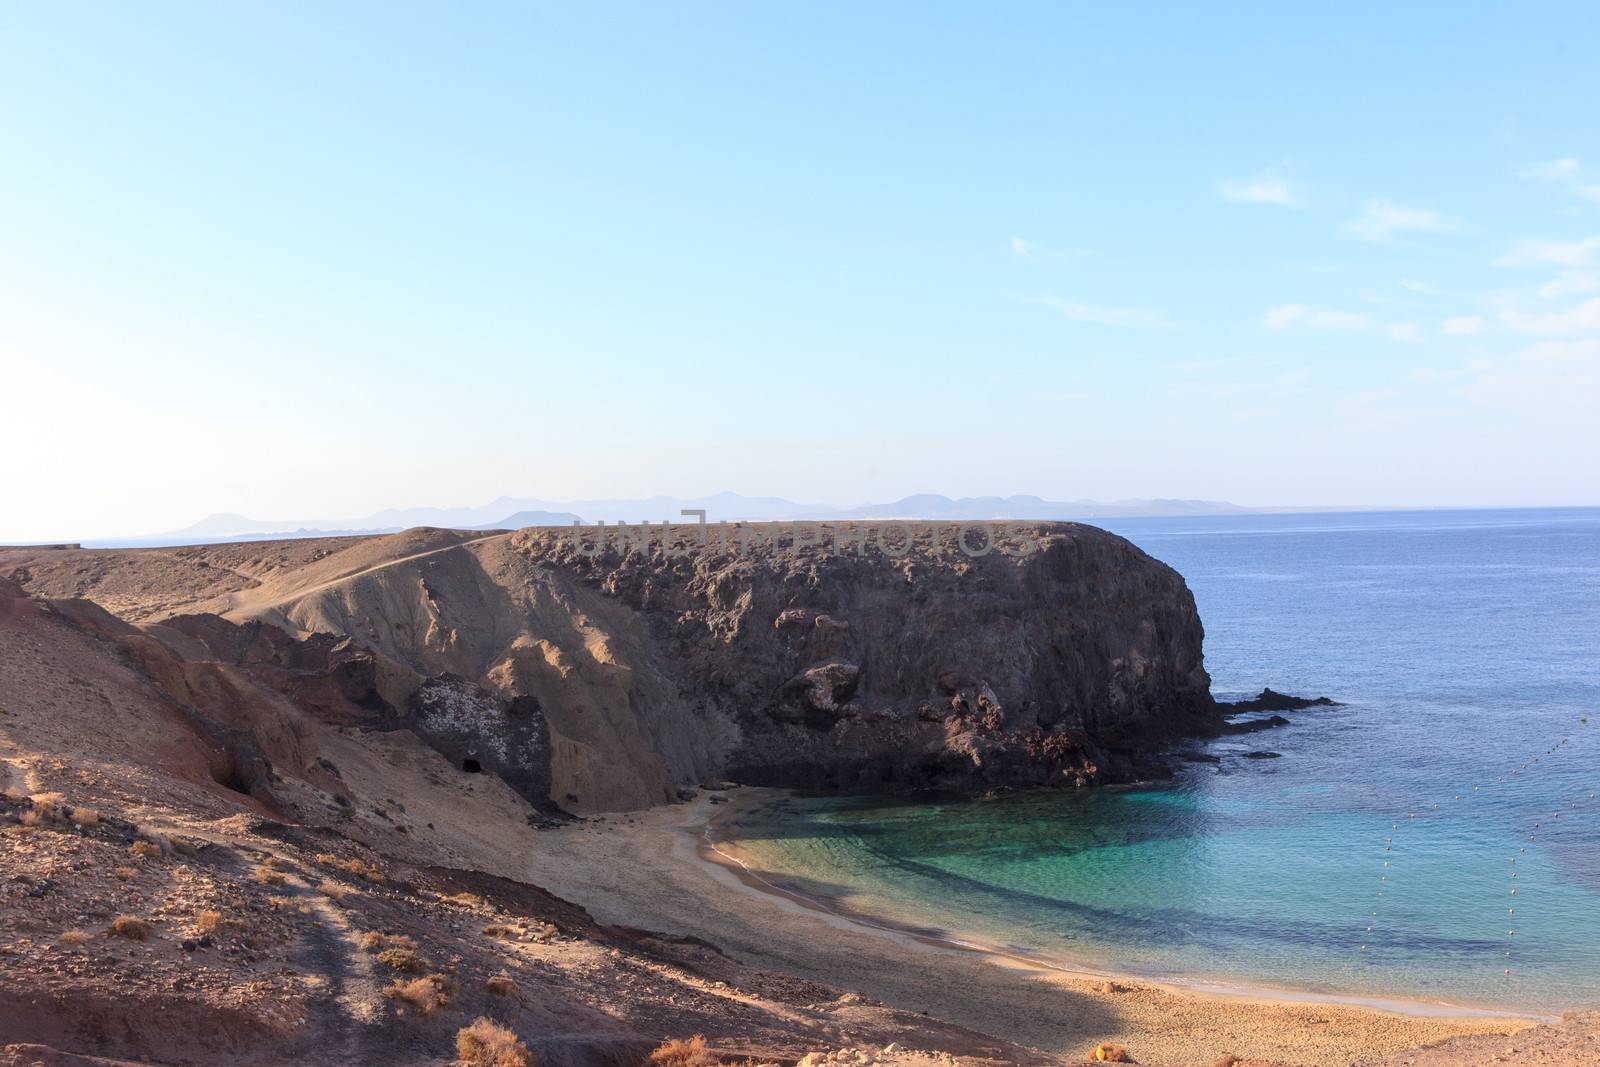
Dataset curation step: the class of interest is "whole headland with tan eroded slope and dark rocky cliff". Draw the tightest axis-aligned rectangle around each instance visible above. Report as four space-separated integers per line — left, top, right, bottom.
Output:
3 523 1219 811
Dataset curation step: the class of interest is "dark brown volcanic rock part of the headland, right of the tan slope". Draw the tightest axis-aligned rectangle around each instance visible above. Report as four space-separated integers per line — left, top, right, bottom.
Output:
514 523 1221 792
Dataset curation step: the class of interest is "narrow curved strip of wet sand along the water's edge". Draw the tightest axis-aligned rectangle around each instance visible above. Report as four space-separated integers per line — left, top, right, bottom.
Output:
697 787 1562 1024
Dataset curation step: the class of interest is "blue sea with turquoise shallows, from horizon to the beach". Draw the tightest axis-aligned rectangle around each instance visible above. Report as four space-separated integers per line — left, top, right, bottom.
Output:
725 509 1600 1011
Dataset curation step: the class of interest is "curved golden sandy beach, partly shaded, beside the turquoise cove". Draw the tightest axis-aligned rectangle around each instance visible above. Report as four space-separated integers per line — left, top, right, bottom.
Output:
528 790 1533 1065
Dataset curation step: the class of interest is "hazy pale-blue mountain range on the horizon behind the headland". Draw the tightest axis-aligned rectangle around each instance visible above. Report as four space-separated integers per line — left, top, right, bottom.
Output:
85 493 1258 547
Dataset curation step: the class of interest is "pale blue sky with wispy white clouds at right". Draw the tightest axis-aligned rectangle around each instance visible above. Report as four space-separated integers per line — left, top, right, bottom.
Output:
0 3 1600 539
